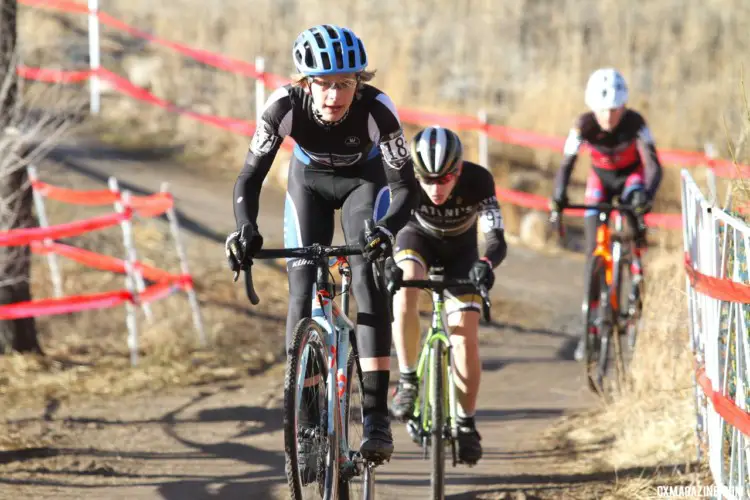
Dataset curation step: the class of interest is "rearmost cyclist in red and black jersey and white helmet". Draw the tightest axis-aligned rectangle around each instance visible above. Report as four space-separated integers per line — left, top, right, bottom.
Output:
550 68 662 361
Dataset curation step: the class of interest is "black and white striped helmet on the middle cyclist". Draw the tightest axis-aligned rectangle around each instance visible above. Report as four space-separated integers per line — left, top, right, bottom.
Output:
411 126 463 179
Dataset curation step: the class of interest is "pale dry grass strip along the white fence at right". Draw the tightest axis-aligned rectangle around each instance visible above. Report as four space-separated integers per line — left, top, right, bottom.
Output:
548 250 697 492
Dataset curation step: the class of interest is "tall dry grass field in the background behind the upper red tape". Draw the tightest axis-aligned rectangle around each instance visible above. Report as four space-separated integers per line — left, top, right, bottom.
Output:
20 0 750 211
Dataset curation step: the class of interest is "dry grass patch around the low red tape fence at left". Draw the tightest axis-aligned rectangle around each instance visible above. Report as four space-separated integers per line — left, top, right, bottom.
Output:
0 186 286 412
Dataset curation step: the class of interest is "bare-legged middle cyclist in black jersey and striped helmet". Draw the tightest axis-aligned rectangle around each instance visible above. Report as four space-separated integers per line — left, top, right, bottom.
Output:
392 127 507 465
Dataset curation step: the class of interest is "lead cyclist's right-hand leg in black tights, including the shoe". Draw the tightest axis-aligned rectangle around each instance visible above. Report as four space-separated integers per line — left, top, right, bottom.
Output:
341 157 393 460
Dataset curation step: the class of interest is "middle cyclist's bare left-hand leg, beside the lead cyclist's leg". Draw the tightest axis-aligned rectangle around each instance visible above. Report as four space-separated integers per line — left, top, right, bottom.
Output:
392 224 432 420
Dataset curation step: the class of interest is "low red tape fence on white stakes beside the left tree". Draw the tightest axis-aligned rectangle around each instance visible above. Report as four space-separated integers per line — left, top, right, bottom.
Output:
0 174 205 365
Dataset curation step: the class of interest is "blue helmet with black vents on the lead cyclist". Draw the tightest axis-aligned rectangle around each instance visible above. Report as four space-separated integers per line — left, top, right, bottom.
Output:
292 24 367 76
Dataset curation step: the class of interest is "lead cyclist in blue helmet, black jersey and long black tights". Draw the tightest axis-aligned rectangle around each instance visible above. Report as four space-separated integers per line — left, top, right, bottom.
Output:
227 25 418 462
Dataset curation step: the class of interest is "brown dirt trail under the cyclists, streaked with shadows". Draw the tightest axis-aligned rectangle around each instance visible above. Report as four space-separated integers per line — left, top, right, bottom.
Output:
0 142 593 500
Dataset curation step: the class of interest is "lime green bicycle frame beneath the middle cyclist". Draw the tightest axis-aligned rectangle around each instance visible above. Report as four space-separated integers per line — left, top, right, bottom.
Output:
414 290 458 450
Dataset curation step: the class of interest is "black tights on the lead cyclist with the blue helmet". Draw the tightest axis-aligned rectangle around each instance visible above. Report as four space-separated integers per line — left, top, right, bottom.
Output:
284 156 391 358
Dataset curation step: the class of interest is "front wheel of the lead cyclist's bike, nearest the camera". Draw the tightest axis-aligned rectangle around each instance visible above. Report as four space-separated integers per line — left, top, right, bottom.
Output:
284 318 338 500
